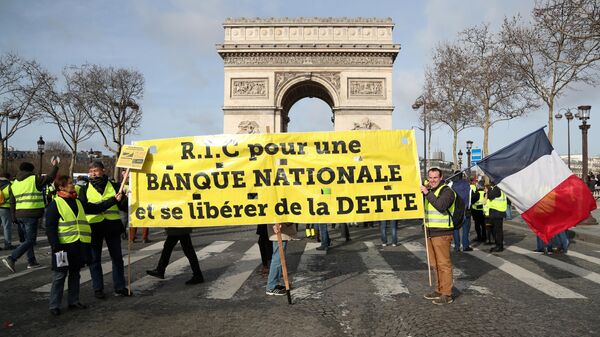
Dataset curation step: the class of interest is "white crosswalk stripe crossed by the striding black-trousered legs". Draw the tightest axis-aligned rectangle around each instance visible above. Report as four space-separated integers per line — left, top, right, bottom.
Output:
131 241 233 292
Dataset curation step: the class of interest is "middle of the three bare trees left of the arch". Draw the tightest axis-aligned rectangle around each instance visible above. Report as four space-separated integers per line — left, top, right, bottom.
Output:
36 67 97 175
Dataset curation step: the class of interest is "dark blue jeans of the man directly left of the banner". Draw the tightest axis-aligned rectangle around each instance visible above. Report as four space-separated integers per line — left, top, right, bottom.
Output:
90 233 125 290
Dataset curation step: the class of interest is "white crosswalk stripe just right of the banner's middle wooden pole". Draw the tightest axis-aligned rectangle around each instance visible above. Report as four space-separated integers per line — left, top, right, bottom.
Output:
291 242 327 300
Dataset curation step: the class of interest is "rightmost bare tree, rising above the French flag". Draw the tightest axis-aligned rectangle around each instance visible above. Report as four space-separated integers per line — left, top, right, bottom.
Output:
502 0 600 141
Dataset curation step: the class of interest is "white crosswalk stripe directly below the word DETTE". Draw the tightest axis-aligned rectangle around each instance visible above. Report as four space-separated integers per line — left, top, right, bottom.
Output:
358 241 410 302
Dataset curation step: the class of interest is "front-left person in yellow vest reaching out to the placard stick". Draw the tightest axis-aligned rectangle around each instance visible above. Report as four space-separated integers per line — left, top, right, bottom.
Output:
46 175 121 316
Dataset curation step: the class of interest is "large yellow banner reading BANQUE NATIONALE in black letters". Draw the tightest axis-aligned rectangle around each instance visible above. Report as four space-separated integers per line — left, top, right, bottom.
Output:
130 130 423 227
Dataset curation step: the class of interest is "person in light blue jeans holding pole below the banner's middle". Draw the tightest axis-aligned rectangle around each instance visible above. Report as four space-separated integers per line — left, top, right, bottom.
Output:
266 223 296 296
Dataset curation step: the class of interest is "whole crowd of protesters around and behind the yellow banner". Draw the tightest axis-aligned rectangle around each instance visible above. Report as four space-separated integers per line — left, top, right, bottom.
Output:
0 161 569 316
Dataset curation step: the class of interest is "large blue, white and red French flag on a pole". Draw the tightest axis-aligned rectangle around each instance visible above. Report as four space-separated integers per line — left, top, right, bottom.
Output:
477 128 596 243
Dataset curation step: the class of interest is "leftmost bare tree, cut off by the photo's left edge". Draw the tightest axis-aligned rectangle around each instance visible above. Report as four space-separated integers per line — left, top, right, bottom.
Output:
0 54 48 172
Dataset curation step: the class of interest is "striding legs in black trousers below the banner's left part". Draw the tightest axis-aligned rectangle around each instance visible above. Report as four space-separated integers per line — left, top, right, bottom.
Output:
146 227 204 285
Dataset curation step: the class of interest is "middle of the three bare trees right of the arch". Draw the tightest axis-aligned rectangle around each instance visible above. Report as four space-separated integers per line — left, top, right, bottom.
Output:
460 24 538 155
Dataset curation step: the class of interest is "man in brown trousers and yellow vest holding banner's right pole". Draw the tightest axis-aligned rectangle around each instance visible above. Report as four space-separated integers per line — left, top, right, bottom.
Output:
421 168 456 305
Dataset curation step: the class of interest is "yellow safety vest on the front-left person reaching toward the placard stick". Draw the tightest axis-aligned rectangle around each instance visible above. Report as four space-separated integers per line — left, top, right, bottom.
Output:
54 197 92 244
